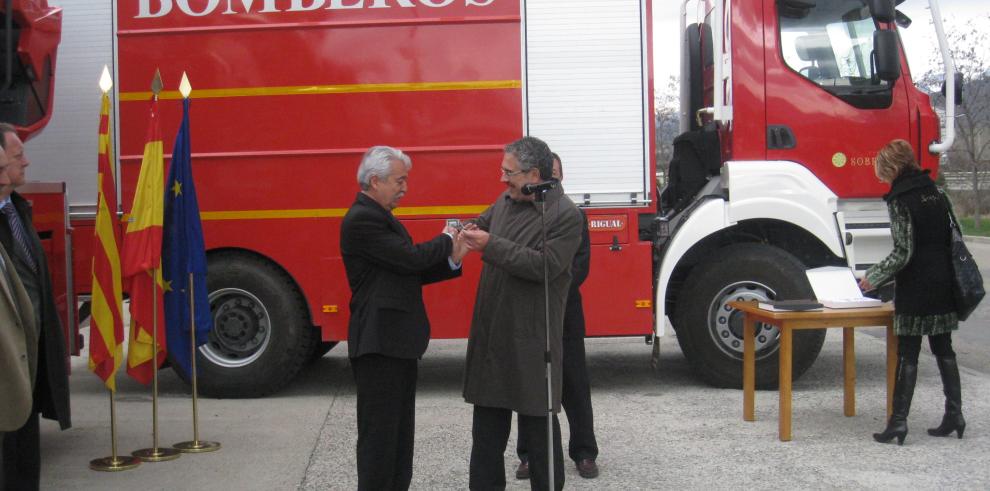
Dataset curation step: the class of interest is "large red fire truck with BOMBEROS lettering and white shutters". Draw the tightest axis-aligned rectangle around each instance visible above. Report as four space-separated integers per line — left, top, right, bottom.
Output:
36 0 951 397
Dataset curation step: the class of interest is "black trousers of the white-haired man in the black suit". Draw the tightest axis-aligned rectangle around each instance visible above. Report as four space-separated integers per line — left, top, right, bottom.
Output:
351 354 418 490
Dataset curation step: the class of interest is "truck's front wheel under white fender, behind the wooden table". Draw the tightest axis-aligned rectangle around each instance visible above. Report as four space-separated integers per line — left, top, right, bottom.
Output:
674 244 825 389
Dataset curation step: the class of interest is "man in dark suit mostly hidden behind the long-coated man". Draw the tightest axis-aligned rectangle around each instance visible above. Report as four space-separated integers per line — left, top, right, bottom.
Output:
516 153 598 479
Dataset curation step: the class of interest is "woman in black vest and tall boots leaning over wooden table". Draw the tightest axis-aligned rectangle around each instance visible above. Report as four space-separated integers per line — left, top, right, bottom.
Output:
860 140 966 444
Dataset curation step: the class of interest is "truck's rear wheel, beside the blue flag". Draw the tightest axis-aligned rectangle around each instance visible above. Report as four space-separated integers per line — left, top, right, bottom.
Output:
190 253 316 398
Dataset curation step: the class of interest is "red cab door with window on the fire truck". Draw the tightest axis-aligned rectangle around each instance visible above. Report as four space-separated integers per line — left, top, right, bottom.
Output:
765 0 917 198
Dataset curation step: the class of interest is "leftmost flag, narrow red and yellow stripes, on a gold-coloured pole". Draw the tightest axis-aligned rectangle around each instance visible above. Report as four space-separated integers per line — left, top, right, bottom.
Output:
89 92 124 390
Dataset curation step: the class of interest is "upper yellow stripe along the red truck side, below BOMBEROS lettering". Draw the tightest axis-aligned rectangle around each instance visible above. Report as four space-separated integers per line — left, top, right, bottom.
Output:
120 80 522 102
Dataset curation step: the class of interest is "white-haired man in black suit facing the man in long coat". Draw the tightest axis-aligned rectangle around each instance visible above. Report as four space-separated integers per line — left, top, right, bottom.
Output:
340 146 467 490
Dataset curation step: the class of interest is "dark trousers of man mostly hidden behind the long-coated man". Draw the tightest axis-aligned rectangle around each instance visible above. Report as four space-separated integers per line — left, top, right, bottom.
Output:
516 329 598 462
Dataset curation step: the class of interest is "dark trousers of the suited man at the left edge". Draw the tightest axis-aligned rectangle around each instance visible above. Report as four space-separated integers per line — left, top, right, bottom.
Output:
0 411 41 491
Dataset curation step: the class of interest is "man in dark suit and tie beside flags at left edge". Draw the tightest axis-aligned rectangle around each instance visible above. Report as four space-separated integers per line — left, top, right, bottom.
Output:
0 123 72 490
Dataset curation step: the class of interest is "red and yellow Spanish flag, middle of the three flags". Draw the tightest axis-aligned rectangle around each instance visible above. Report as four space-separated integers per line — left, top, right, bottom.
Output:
121 97 166 384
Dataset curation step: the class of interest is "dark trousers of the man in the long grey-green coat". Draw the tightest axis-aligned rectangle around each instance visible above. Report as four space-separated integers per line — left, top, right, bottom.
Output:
469 405 564 491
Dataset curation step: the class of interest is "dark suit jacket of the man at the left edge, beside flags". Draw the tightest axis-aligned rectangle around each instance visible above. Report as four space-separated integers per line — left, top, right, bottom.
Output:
0 191 72 430
